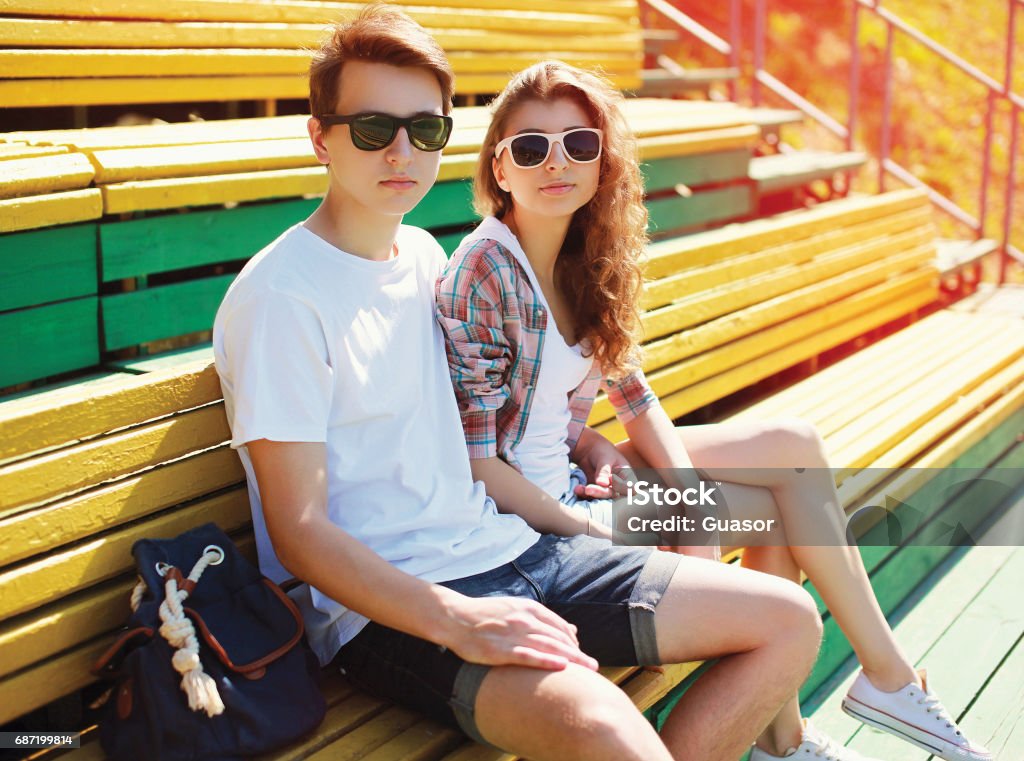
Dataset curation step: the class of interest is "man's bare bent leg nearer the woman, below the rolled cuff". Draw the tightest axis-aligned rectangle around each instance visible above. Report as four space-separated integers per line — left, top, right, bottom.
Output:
654 557 821 761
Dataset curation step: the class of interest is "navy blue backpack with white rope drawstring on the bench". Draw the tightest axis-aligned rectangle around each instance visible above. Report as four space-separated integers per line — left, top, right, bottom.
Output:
92 523 326 761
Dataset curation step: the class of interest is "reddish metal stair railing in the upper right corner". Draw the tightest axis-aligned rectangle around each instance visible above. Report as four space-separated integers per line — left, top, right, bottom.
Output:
643 0 1024 284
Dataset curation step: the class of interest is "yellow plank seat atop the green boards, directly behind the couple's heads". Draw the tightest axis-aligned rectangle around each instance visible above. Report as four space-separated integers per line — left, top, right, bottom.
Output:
0 99 760 226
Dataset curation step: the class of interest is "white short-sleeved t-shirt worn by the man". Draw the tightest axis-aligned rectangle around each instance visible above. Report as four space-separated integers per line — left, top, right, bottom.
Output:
213 224 539 664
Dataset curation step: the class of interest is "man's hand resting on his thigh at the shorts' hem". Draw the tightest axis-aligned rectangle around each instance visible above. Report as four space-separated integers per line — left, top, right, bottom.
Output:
441 595 597 671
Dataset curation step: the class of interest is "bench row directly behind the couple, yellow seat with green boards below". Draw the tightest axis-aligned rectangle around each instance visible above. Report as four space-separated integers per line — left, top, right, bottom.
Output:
0 99 759 388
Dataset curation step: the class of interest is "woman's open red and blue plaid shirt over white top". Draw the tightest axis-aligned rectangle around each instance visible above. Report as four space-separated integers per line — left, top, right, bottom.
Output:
436 233 658 470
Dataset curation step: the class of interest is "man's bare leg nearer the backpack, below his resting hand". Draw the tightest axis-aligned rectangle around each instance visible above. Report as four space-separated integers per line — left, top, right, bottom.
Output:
475 664 679 761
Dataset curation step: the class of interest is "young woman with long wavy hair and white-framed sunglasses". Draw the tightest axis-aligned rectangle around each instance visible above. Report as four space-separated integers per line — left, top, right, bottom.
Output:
437 61 991 761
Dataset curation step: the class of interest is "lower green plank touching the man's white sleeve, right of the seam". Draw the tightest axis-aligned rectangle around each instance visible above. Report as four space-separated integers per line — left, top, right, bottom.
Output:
101 274 236 349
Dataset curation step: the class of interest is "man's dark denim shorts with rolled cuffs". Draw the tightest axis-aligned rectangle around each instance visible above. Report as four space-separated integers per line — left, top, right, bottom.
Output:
335 535 679 744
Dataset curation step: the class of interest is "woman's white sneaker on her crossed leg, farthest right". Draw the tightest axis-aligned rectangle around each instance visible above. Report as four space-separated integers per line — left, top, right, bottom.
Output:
843 670 992 761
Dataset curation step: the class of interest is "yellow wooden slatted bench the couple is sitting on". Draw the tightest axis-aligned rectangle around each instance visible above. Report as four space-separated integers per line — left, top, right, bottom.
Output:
6 184 1024 759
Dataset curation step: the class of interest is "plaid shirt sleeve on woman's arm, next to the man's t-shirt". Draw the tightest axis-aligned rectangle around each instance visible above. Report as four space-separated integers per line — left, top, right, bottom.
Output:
435 242 512 459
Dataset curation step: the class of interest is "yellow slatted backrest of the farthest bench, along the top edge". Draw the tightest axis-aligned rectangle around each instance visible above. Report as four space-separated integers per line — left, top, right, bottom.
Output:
0 0 643 107
